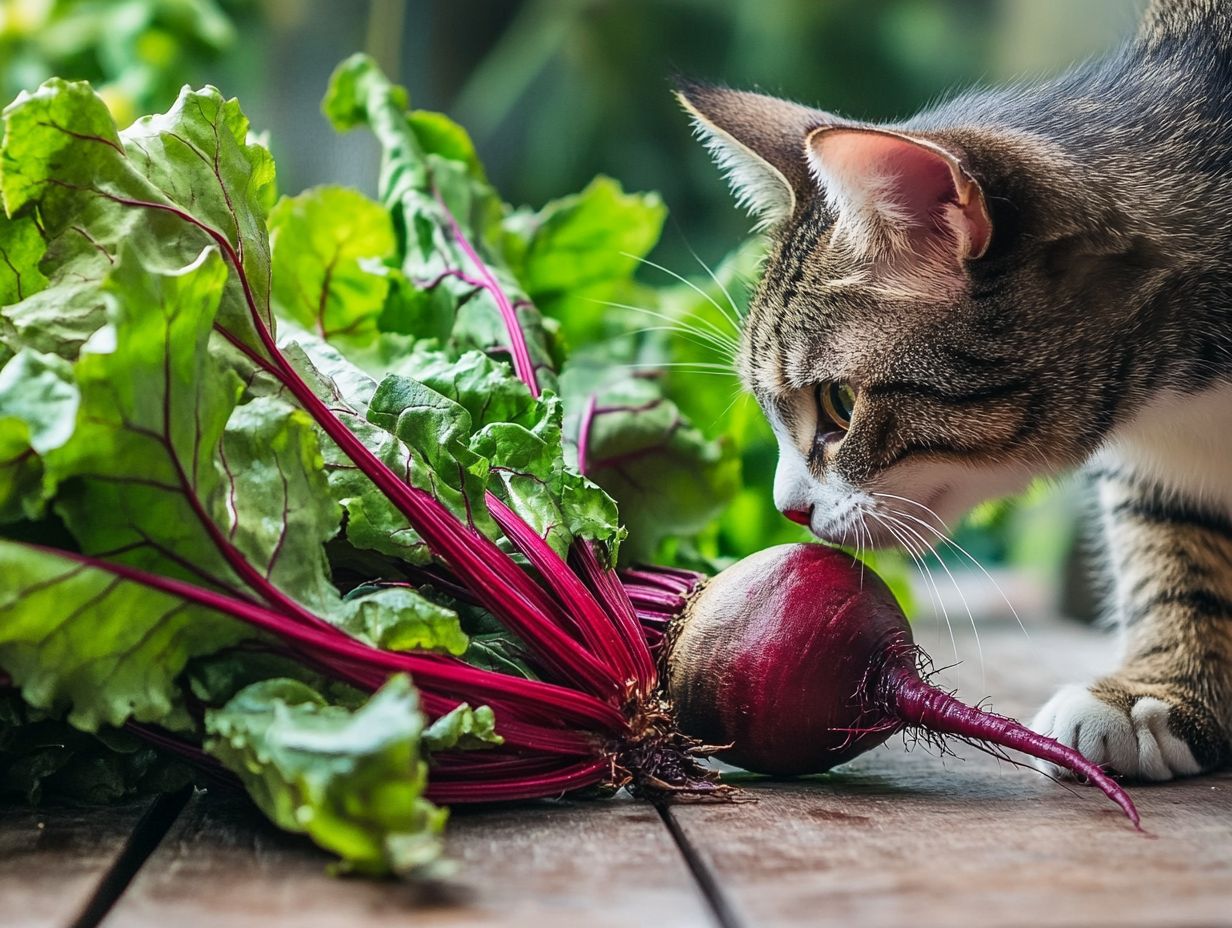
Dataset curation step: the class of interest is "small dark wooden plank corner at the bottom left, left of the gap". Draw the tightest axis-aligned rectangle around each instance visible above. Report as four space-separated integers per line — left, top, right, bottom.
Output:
0 799 175 928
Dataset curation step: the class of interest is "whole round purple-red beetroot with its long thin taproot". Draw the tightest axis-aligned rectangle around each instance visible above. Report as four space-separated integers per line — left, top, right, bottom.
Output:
650 545 1138 824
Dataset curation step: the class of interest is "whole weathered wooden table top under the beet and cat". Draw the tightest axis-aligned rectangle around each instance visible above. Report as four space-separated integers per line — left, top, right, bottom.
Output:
0 611 1232 928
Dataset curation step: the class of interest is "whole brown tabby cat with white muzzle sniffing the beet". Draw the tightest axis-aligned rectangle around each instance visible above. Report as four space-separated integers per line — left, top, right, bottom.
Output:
678 0 1232 780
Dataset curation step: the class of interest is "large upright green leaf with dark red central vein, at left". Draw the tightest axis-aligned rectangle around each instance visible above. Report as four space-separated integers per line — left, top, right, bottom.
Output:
47 250 241 579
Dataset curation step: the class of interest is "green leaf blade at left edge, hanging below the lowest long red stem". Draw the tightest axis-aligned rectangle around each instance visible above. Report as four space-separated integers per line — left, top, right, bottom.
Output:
0 540 249 731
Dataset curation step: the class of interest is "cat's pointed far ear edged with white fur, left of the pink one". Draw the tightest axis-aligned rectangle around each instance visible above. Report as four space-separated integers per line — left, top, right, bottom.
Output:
676 80 838 228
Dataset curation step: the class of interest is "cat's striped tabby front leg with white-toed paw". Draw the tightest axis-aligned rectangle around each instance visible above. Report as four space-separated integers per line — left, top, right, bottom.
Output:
1032 468 1232 780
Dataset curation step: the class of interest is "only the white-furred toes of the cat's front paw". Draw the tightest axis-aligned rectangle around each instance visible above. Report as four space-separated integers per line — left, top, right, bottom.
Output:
1031 684 1201 780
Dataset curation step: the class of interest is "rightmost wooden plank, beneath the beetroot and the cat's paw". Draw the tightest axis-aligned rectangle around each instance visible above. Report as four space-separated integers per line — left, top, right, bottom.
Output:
670 622 1232 928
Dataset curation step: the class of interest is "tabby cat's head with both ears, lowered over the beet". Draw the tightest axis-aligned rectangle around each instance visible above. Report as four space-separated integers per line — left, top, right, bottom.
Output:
680 85 1143 545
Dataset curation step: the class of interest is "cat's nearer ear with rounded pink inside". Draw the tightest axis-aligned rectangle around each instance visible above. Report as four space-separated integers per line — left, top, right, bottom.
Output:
808 127 993 263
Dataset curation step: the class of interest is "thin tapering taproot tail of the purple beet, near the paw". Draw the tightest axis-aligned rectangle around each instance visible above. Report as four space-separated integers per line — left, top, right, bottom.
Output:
881 664 1138 827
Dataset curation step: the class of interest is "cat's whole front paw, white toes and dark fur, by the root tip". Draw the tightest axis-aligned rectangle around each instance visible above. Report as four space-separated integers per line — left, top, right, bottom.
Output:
1031 682 1223 780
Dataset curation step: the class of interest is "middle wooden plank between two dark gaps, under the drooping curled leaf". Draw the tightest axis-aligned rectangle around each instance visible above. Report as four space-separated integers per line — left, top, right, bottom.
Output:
103 794 712 928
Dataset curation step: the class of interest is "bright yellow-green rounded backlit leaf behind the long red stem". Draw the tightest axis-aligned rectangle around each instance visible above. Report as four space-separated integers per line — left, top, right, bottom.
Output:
270 187 395 346
